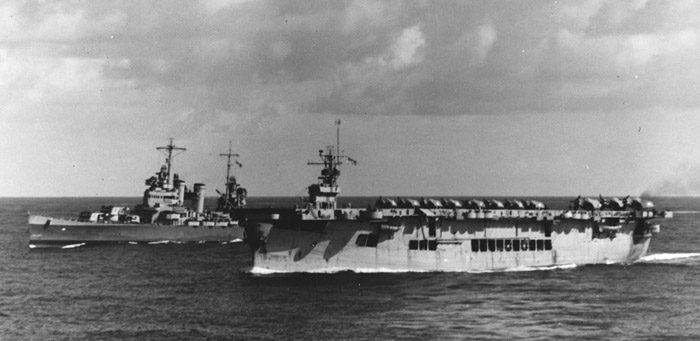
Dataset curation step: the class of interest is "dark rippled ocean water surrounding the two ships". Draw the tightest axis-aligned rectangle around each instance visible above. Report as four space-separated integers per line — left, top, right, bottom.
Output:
0 198 700 340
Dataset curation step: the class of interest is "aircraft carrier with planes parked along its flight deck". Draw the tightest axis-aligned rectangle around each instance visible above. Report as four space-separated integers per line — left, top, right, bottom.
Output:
241 122 672 273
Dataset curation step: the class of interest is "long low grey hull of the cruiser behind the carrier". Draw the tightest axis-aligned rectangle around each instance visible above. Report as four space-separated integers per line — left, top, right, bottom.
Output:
29 216 243 247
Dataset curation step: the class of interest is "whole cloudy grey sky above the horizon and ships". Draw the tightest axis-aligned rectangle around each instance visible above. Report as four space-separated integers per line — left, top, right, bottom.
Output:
0 0 700 196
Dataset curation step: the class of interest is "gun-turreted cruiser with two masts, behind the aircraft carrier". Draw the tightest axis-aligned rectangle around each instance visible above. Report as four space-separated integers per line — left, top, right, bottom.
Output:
29 139 247 248
